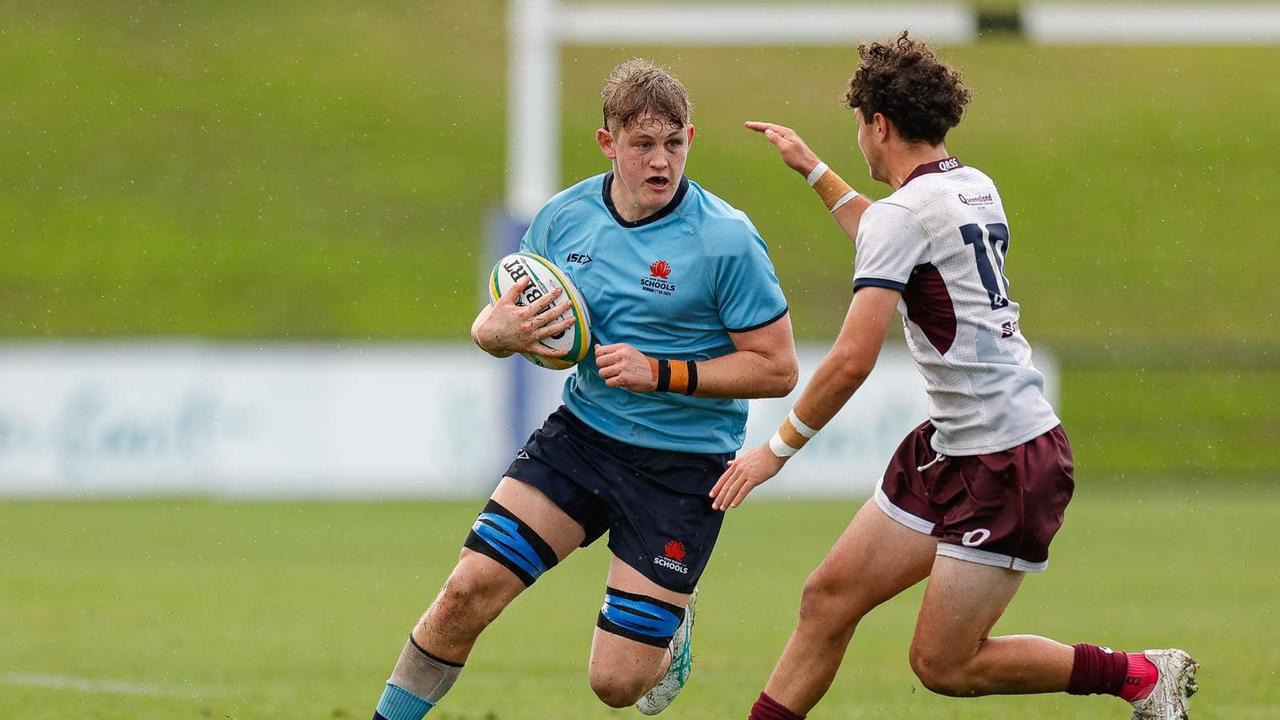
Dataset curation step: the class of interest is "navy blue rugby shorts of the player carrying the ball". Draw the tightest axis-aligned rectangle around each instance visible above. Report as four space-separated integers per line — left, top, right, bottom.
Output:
506 406 733 593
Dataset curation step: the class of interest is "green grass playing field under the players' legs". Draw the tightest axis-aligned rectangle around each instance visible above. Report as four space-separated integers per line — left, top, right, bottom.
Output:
0 491 1280 720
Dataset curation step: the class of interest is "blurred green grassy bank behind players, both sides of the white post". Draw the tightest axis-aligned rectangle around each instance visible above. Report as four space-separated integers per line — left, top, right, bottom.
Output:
0 0 1280 357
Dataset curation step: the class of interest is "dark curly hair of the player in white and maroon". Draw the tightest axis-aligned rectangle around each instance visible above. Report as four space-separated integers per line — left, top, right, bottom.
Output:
845 31 969 145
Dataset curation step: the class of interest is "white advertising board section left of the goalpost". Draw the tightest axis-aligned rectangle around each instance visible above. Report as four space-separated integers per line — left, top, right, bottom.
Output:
0 343 506 497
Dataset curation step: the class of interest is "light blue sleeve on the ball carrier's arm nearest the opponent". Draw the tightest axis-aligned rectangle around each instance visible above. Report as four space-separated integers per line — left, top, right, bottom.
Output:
713 223 787 333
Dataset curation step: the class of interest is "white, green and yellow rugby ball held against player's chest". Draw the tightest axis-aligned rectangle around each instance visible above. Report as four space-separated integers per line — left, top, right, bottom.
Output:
489 252 591 370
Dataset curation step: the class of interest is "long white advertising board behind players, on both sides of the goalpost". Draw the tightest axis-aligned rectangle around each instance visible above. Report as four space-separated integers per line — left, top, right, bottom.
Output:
0 342 1056 498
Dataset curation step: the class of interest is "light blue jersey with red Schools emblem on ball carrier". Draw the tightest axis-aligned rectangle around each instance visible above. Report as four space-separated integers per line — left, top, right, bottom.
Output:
520 173 787 454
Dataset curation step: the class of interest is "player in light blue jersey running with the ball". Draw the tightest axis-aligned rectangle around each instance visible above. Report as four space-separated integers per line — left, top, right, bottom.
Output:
374 60 797 720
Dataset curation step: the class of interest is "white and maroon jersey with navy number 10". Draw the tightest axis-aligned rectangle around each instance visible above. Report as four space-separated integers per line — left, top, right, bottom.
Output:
854 158 1059 456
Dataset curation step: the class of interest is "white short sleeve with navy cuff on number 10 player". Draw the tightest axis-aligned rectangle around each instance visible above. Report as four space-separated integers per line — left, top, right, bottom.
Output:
854 202 928 292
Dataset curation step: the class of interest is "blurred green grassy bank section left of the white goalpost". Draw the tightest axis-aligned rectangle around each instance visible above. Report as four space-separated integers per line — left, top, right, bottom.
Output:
0 3 503 338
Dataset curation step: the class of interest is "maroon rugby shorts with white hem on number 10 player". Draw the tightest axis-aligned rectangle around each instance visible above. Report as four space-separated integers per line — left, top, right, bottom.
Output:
876 421 1075 573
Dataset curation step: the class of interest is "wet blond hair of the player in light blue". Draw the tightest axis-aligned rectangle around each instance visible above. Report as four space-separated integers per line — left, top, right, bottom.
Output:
600 58 692 131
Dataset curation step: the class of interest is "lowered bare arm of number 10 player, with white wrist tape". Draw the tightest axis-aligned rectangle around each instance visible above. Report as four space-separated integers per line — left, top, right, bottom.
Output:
710 287 901 510
